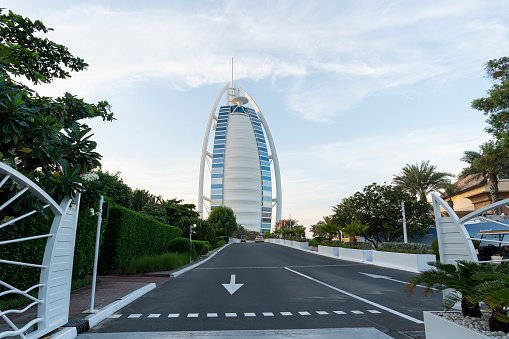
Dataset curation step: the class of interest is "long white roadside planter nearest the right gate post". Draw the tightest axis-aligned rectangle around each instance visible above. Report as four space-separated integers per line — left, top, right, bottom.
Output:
372 251 436 273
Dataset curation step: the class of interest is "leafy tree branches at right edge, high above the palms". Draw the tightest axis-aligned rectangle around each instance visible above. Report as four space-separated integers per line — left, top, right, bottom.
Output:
472 57 509 140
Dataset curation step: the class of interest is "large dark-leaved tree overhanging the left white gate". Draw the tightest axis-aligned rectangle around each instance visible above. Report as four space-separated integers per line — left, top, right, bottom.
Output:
0 9 114 208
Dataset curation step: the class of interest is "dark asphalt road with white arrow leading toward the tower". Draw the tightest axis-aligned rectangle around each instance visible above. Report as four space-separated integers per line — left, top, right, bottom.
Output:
83 243 441 338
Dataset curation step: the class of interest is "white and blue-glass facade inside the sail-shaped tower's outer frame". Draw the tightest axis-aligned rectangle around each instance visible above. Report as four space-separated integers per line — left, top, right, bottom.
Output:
211 106 272 233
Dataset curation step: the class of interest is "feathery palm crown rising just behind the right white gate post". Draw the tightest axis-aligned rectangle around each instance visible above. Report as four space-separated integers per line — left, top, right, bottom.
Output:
392 160 452 201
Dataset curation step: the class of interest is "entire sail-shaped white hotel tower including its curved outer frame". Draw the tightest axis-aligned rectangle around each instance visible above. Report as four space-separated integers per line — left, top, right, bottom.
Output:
198 79 281 233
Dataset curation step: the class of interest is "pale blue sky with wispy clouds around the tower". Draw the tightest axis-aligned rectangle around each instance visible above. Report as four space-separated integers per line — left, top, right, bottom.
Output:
1 0 509 226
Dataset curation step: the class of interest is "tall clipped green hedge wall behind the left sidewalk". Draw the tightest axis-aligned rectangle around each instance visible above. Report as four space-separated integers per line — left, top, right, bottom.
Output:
99 206 182 274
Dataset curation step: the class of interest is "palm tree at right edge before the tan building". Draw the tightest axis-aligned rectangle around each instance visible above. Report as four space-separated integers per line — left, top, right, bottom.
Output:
459 141 509 213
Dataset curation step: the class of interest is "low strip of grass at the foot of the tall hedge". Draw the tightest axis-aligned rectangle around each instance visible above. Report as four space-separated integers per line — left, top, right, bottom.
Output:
121 253 189 274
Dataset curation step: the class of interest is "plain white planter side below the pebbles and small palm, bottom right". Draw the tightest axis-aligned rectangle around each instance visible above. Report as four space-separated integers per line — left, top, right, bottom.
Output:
423 311 492 339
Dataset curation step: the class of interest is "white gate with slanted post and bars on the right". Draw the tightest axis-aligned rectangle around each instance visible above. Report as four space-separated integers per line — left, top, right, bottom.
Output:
431 193 509 264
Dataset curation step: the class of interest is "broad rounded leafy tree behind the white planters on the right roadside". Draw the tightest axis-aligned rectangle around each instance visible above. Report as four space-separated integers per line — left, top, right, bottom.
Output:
333 183 433 247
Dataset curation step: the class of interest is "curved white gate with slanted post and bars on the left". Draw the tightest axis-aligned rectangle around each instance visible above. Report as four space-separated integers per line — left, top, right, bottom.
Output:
0 162 80 338
